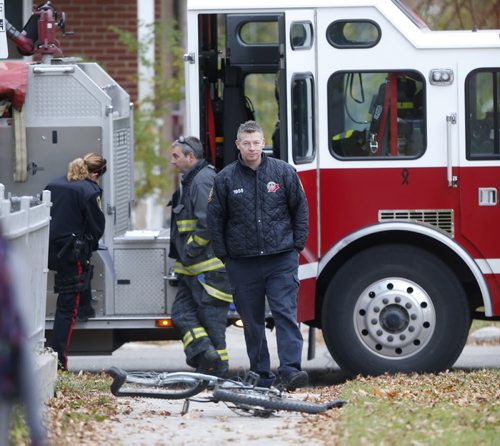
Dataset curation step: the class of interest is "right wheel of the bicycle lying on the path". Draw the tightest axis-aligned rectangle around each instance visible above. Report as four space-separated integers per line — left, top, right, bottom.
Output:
213 387 346 414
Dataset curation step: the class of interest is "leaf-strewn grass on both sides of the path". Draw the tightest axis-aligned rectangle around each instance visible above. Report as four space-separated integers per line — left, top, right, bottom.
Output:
7 324 500 446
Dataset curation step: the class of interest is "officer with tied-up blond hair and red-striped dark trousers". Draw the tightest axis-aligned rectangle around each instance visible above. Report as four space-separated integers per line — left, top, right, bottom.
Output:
46 153 106 370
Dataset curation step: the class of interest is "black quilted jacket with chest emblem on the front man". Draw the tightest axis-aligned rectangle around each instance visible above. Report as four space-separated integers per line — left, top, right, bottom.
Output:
208 154 309 259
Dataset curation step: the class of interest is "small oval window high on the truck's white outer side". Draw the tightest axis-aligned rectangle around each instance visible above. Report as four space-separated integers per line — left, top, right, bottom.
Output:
326 20 382 48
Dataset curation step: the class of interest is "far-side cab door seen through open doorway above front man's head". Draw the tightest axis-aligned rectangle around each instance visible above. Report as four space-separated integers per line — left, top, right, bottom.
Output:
223 13 286 165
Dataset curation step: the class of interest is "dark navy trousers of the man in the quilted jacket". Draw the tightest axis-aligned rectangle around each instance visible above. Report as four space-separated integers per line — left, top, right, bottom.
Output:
226 251 303 377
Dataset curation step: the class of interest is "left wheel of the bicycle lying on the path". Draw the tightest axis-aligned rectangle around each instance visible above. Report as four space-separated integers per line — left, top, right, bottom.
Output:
107 367 209 400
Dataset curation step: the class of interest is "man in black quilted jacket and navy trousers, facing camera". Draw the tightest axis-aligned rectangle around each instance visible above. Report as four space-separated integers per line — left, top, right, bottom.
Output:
208 121 309 390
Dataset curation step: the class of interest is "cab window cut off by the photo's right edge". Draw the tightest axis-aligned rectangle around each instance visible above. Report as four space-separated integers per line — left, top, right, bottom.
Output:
465 70 500 160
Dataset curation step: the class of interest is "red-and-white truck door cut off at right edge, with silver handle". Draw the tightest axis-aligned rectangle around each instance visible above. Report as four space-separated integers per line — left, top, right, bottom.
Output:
457 64 500 295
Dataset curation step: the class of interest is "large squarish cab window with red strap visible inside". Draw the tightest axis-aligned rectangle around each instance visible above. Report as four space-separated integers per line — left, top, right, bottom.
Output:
328 71 426 159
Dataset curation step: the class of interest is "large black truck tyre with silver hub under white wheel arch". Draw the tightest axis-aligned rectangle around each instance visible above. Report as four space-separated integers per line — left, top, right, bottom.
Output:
322 244 471 375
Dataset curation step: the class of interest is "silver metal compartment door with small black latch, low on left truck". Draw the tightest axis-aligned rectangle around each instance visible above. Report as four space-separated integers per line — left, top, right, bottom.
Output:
114 249 166 316
